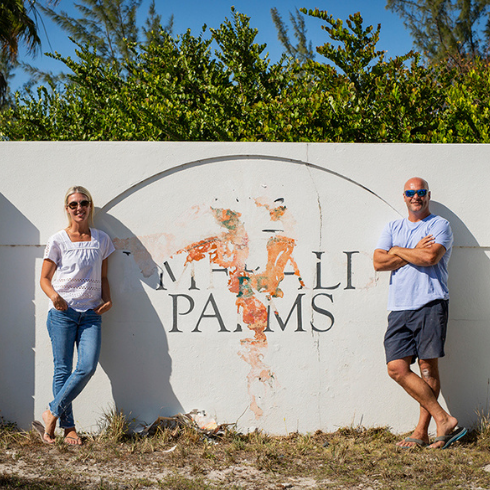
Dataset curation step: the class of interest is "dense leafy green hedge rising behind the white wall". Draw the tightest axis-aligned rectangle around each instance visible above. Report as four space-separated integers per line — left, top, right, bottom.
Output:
0 10 490 143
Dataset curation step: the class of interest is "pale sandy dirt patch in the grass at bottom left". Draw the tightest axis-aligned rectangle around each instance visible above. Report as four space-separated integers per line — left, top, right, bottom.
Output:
0 444 338 490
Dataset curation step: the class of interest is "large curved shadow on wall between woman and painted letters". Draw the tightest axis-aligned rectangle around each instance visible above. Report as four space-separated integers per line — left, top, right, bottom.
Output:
95 211 183 423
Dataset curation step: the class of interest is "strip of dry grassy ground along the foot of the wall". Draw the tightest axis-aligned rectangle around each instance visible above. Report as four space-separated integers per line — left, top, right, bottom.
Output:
0 411 490 490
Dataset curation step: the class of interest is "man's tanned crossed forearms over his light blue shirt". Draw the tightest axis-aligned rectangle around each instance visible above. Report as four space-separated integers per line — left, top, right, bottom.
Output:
373 235 446 271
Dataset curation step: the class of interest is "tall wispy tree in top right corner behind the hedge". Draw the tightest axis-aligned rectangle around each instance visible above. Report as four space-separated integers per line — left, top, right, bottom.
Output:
386 0 490 63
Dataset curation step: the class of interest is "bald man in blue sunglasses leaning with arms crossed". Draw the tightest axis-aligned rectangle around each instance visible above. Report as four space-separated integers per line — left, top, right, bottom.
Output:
373 177 467 449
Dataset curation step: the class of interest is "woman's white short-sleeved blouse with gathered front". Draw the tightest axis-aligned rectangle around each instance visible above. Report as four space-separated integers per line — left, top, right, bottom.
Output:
44 228 114 311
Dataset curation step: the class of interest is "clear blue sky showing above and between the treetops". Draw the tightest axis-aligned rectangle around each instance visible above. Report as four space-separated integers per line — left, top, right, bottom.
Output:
11 0 412 90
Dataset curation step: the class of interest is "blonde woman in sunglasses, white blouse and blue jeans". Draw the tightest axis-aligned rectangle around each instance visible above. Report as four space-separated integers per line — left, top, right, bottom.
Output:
34 186 114 445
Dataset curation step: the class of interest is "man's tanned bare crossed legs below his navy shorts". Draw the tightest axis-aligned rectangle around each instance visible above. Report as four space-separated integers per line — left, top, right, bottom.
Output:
388 357 458 448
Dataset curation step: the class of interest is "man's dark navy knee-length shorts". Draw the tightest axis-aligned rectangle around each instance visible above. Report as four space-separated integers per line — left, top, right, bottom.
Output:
384 299 449 363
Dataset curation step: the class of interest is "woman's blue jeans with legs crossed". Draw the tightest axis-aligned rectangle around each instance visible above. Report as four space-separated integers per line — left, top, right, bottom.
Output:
47 308 102 429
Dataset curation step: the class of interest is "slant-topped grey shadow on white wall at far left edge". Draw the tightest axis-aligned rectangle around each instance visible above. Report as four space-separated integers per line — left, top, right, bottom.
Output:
0 194 43 427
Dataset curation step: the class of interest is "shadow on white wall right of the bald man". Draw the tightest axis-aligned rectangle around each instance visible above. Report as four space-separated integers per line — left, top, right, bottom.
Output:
431 202 490 426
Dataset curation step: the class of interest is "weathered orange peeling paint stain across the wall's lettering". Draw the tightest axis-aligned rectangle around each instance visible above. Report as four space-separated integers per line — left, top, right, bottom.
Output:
179 205 304 418
